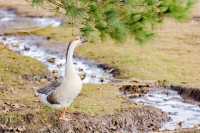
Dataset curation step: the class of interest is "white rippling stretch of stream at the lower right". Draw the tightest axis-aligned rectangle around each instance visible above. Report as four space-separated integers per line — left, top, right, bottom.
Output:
131 89 200 130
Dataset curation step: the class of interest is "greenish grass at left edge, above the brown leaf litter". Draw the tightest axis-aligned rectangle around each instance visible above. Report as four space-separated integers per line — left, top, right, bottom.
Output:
0 44 48 87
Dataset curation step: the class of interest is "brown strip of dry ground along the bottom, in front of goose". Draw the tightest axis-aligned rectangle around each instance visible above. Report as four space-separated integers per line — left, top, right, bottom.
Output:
0 107 168 133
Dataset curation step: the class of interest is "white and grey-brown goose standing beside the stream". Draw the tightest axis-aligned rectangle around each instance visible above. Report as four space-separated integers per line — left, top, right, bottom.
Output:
37 37 86 120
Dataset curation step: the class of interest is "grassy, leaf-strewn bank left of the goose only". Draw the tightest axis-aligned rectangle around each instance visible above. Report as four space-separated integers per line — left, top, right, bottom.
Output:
0 44 51 127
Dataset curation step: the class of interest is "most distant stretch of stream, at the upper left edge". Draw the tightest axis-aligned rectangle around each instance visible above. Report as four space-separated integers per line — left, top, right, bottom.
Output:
0 10 63 34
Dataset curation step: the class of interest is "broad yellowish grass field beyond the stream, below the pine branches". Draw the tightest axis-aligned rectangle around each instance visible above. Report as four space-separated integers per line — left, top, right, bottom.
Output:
30 16 200 85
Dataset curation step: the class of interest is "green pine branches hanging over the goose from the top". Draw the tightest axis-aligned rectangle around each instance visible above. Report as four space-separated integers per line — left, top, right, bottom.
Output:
32 0 194 41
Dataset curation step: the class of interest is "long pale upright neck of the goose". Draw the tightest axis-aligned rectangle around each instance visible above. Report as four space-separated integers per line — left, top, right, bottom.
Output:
65 43 75 78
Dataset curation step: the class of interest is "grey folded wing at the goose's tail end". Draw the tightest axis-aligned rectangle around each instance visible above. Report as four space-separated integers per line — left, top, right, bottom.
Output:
37 81 61 95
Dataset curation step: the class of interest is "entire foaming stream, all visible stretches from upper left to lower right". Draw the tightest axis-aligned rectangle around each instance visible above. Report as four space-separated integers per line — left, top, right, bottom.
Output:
0 10 200 130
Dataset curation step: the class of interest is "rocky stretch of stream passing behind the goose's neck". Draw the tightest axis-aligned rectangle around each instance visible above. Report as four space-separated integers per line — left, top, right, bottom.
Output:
0 36 112 83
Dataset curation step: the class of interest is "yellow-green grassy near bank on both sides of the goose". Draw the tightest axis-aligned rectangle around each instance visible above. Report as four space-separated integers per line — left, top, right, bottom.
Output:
0 45 136 130
